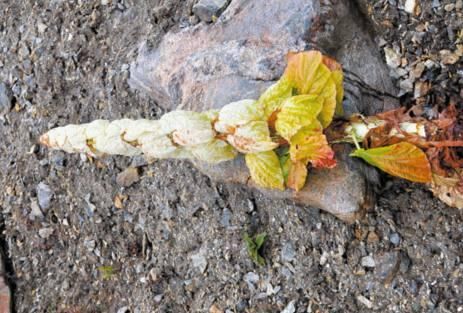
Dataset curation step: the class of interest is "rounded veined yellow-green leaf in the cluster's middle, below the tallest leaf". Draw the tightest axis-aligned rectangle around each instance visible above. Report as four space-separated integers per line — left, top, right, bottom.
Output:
275 95 322 140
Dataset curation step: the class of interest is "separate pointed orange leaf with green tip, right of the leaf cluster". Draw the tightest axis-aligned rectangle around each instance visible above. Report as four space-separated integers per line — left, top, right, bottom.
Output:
351 142 432 183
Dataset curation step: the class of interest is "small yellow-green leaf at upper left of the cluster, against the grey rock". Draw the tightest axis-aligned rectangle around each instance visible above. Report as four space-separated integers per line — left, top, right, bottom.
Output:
258 78 293 119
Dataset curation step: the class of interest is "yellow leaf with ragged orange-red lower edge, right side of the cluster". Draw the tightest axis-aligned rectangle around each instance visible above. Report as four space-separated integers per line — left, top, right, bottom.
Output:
289 122 336 168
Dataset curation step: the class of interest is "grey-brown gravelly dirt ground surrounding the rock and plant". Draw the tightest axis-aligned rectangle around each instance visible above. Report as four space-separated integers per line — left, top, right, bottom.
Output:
0 0 463 313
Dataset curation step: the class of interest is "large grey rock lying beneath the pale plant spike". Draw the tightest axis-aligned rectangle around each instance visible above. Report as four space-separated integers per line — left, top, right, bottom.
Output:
129 0 397 222
